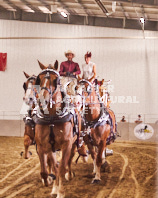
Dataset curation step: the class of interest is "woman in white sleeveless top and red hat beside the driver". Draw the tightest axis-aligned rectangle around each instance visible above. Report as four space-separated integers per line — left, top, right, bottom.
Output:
82 52 96 83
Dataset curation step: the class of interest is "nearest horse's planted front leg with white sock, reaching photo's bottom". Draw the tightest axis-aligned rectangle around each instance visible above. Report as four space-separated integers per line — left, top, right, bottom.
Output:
57 140 72 198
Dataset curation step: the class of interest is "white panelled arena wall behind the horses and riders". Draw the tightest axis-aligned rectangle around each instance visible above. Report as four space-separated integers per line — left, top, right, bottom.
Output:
0 20 158 120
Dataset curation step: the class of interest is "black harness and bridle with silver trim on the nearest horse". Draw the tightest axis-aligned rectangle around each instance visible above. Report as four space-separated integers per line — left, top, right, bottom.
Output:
33 69 79 152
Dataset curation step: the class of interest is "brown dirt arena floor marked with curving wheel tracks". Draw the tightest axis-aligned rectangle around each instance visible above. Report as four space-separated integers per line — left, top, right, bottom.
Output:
0 137 158 198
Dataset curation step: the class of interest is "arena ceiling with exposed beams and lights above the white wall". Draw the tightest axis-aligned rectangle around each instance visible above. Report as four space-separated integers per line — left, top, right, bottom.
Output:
0 0 158 31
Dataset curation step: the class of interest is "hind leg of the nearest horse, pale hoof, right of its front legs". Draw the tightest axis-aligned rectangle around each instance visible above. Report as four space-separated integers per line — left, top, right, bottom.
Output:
65 143 77 181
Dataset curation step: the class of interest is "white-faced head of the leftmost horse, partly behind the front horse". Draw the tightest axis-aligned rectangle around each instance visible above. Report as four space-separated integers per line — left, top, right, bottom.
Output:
23 72 37 106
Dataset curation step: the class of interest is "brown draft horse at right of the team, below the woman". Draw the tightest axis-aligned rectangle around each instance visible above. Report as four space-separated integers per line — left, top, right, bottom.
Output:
76 80 110 183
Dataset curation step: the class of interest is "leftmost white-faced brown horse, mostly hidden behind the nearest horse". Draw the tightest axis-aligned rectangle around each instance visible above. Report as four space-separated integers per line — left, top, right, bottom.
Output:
21 72 36 159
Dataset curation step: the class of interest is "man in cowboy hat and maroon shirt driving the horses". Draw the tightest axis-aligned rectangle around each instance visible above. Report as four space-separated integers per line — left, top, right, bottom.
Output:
59 50 81 77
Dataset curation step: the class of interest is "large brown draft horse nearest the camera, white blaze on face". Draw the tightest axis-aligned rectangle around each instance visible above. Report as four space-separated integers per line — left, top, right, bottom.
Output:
35 61 81 198
